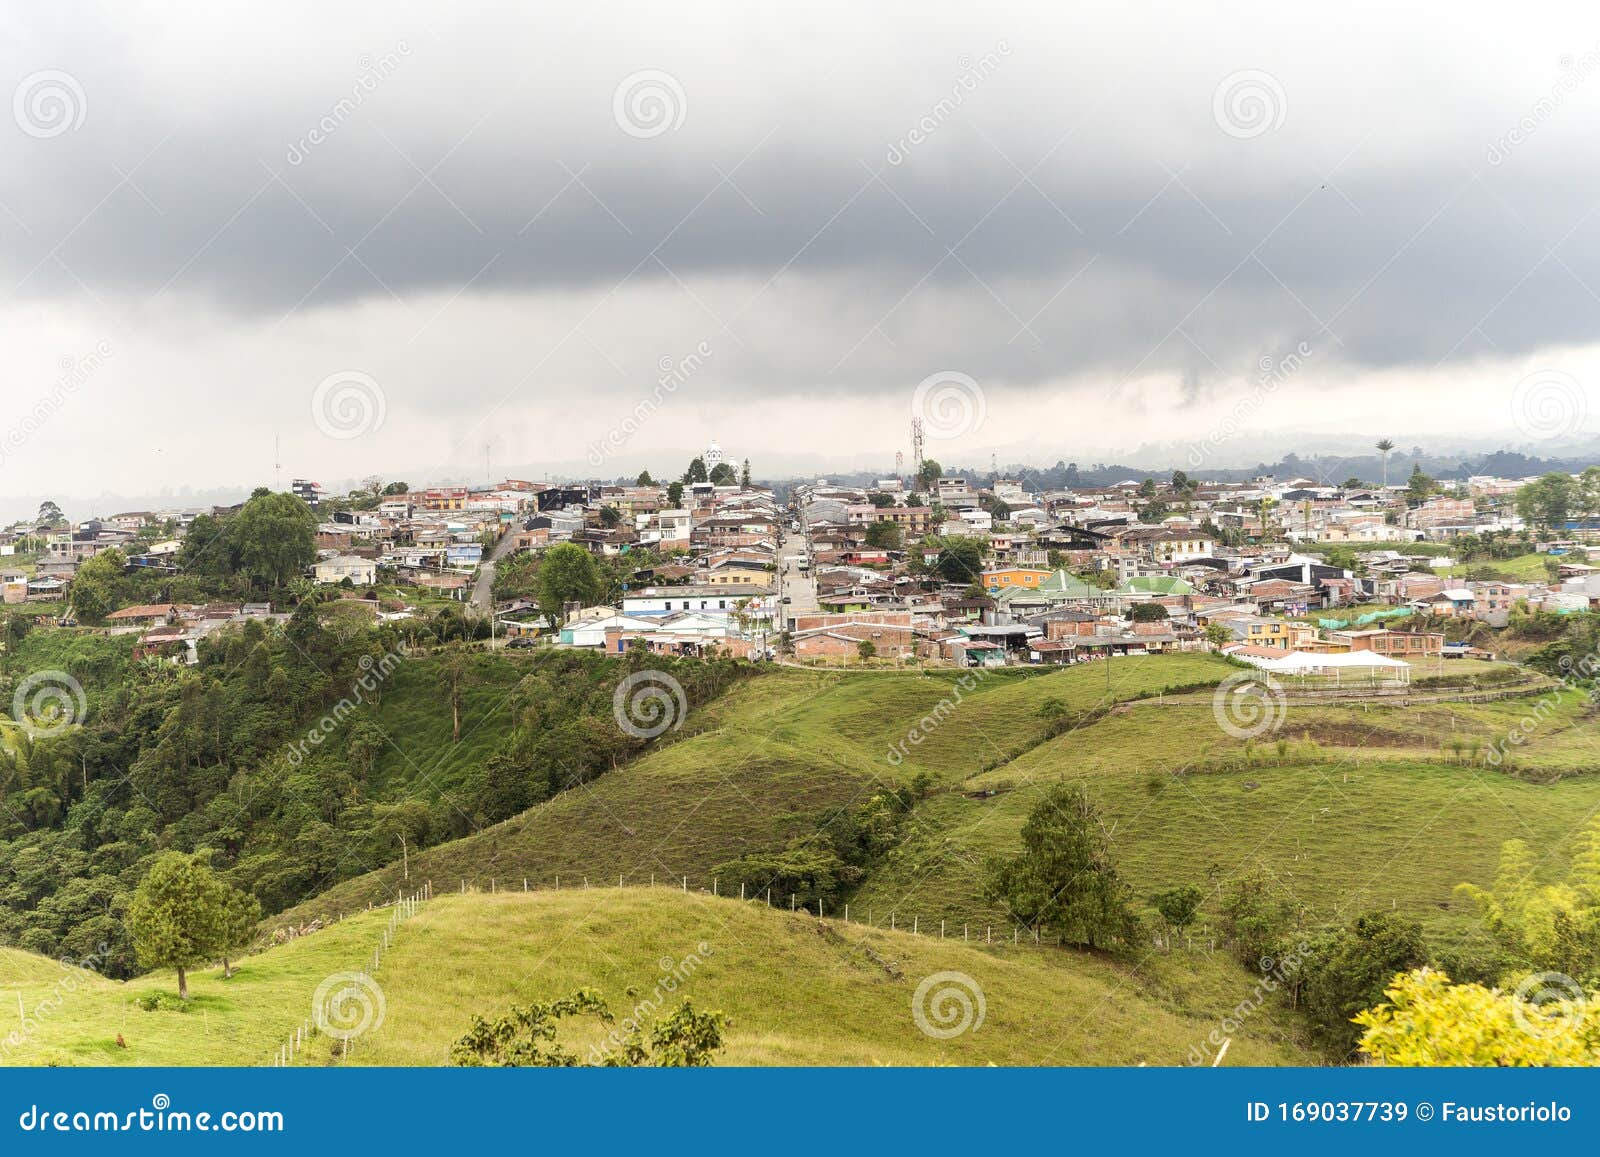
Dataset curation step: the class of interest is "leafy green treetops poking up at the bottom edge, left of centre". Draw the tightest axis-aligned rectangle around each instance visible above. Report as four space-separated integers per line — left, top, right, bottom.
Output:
450 989 728 1069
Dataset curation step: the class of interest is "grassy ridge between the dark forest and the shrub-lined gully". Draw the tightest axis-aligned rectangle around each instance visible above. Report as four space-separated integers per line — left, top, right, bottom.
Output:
270 655 1230 925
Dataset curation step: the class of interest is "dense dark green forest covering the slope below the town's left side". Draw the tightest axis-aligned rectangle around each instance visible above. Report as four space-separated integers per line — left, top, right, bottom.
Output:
0 602 741 976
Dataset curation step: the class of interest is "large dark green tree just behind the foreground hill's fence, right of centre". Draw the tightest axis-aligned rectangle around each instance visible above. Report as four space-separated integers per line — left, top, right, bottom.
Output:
984 784 1139 949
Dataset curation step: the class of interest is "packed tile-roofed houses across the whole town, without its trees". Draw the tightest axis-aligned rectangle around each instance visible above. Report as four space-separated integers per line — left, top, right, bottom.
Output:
12 460 1600 669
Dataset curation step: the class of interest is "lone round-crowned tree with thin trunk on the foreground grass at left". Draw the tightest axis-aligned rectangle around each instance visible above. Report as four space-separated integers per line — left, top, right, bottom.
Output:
128 851 227 1000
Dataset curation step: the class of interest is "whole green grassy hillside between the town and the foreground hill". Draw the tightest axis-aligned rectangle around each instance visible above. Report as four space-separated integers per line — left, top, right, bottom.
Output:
285 656 1600 944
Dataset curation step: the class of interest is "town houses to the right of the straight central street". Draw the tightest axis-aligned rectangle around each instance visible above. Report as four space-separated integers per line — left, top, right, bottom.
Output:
656 478 1600 679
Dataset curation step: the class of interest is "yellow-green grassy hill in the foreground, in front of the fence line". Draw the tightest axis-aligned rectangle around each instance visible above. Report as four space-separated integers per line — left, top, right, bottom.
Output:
0 888 1317 1064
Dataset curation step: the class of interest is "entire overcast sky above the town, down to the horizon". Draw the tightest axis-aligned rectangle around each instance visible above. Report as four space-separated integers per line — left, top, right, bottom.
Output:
0 2 1600 512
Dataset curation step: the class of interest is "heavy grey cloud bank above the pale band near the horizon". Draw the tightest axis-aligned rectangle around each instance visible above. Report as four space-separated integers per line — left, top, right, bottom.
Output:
0 6 1600 397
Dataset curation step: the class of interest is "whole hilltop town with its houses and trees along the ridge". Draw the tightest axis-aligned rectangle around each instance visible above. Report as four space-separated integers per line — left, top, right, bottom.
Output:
9 443 1600 685
